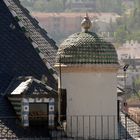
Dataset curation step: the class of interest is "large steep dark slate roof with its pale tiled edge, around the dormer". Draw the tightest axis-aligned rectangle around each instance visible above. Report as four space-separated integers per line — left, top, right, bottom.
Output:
0 0 57 139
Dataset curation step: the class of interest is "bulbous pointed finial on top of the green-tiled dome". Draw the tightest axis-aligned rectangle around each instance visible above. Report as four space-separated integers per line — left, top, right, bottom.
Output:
81 12 92 32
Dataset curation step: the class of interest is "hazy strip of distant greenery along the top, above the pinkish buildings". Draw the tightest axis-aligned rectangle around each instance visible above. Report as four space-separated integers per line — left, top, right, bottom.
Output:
20 0 125 14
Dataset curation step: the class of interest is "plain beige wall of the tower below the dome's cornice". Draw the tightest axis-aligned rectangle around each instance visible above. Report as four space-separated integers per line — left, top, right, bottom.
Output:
62 72 117 139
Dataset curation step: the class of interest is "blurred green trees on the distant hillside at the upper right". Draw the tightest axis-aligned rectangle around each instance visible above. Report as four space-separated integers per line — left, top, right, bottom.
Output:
113 0 140 44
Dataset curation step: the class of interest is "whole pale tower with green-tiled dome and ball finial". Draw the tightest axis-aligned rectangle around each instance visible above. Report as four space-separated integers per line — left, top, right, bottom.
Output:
55 15 118 139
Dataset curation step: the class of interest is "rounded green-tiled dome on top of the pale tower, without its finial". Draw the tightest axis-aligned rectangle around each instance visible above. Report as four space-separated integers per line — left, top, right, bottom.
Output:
56 31 118 64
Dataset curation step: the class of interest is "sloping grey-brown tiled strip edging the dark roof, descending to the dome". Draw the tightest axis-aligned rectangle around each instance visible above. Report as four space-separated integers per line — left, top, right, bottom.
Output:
3 0 58 80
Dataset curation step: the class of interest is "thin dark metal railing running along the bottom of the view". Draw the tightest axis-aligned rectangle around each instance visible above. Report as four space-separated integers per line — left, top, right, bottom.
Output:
0 113 140 140
